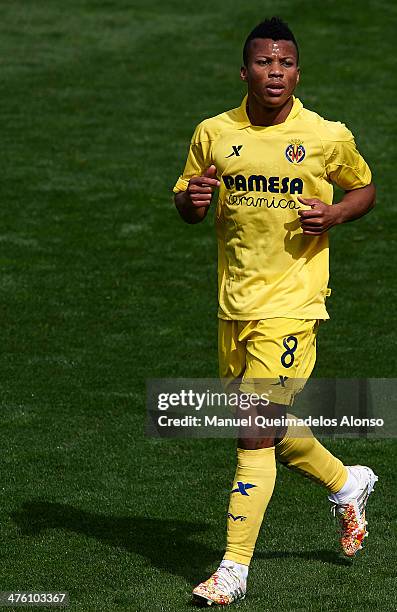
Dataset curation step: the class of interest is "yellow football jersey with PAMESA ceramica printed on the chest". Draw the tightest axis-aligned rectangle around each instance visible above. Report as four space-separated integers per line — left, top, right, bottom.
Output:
174 97 371 320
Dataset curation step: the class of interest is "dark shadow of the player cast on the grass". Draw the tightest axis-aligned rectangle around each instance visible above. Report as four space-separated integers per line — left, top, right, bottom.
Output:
11 500 349 584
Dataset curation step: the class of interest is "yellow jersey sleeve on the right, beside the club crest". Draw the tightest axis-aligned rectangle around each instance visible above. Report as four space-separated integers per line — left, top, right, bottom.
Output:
325 123 372 191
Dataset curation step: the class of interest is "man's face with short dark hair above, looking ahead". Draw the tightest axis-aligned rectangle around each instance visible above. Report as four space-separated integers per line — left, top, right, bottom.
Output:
240 38 299 108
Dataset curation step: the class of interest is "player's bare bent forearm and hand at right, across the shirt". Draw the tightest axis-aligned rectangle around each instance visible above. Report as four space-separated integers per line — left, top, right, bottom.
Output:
298 183 376 236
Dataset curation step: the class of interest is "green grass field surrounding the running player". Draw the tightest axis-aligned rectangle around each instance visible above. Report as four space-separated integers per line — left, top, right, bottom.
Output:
0 0 397 612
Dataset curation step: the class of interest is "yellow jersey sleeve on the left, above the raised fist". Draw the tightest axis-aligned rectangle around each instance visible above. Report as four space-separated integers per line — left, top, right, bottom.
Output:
173 123 212 193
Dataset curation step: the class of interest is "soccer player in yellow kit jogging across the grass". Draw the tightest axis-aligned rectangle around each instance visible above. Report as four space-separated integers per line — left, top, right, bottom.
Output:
174 17 377 605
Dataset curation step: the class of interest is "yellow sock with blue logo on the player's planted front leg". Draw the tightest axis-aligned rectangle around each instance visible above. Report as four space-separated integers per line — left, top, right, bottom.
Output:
223 446 276 565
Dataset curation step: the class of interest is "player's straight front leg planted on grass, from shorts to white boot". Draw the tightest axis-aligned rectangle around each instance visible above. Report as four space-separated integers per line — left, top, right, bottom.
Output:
193 320 278 605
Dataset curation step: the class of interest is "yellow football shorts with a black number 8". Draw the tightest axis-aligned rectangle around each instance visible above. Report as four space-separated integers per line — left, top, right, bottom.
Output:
218 318 319 405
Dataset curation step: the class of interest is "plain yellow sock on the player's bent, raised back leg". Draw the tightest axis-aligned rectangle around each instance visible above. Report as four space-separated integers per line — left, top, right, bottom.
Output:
276 414 347 493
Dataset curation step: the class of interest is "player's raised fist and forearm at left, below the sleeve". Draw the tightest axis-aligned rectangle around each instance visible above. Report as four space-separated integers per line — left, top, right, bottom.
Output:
174 166 220 223
